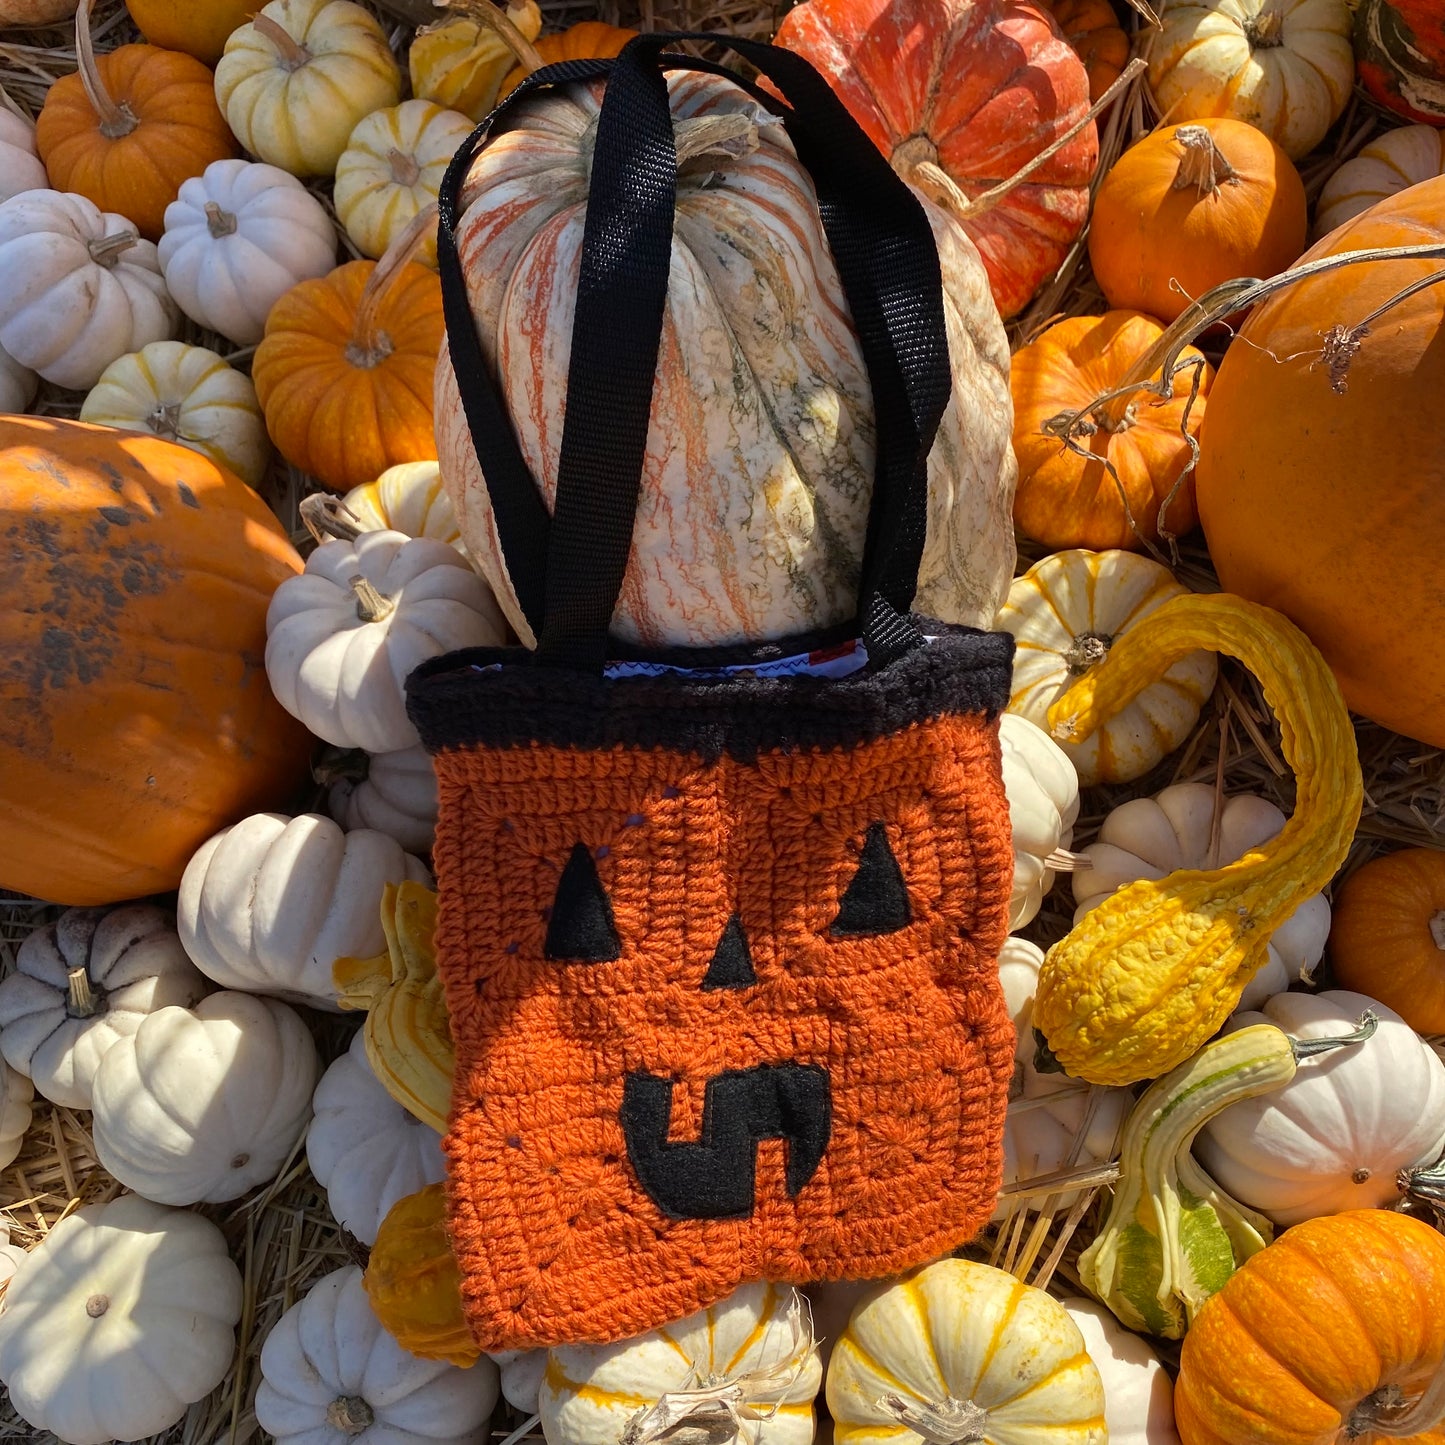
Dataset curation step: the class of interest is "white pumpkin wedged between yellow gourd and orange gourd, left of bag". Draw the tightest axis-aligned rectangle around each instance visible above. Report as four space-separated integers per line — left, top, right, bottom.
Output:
306 1029 447 1244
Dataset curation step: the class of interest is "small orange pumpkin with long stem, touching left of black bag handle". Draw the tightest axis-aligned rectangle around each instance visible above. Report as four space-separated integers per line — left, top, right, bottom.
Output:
251 207 444 491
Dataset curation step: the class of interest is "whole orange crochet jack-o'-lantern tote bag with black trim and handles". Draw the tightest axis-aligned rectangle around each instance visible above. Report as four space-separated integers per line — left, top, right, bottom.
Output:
409 36 1014 1350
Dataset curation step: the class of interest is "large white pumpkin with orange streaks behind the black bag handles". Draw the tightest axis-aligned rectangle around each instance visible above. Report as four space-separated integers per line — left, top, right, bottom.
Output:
436 74 1016 646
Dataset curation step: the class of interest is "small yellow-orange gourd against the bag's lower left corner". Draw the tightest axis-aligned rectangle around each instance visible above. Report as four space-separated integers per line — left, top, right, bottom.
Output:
364 1183 481 1367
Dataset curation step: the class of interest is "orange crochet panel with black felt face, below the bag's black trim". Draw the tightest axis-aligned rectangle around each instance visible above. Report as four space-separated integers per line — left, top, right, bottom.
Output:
436 676 1013 1350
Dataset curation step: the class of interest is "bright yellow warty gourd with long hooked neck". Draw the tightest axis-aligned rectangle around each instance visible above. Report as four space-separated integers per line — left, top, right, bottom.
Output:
1033 592 1364 1084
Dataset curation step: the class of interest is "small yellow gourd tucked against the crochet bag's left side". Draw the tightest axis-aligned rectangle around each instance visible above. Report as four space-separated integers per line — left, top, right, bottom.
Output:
331 883 457 1134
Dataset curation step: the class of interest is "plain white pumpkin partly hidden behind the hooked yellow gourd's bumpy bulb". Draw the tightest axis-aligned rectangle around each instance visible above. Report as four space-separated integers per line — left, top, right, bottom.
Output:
1072 783 1329 1009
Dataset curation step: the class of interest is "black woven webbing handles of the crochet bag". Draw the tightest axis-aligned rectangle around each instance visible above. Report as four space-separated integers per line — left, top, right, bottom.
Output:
438 32 951 672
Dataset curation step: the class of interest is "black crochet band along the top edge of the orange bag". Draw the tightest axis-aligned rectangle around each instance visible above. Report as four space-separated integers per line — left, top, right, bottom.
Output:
406 618 1013 763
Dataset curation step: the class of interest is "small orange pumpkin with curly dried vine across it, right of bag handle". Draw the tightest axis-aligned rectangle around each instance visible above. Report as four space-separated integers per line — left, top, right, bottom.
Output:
1009 311 1214 551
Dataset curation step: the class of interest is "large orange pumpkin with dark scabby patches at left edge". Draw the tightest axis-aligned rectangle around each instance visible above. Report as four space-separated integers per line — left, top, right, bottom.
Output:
0 416 309 903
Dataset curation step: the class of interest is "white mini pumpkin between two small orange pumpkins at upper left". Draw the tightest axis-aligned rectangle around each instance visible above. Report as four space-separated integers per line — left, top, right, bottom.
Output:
159 160 337 347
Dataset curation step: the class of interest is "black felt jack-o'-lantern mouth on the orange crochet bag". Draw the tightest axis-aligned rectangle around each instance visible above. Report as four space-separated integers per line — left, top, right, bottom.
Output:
621 1064 832 1220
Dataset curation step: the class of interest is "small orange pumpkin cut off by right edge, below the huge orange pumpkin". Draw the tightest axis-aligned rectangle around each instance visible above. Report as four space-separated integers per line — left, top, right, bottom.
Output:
1329 848 1445 1033
